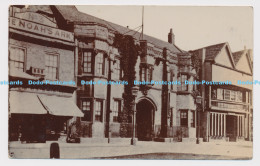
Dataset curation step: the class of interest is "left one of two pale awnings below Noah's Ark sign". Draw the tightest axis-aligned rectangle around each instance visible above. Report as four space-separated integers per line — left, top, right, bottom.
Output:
9 91 47 114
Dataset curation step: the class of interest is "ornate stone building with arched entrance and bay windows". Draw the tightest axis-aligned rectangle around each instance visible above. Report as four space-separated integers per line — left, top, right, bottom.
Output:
52 6 196 141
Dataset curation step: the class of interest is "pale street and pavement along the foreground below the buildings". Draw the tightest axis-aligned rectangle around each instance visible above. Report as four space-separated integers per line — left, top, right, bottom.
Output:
9 141 253 159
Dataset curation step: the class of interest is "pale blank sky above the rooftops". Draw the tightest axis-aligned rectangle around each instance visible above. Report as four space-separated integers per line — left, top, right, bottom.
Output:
76 6 253 52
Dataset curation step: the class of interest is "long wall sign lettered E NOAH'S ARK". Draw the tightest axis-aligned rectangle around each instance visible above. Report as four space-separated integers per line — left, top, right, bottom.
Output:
9 17 74 42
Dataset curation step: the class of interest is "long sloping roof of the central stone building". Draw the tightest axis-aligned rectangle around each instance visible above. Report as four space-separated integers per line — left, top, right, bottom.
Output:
53 5 182 53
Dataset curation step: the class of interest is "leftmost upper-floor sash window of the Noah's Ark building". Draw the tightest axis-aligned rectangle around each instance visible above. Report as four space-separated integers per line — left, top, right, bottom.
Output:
9 47 25 71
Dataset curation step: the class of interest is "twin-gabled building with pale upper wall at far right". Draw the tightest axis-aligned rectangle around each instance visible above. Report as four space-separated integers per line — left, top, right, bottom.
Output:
191 43 253 141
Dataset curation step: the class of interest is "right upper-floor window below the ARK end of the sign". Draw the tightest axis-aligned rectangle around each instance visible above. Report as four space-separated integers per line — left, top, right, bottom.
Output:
45 54 58 80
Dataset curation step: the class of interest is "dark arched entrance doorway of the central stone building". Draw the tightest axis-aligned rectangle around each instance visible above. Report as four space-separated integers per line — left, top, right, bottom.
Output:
136 99 155 141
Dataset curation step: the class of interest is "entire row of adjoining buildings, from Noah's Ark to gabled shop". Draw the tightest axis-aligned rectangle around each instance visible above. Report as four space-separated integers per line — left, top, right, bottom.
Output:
9 6 253 142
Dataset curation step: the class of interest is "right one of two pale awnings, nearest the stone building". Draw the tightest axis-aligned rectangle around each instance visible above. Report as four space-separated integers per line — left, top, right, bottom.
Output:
38 95 84 117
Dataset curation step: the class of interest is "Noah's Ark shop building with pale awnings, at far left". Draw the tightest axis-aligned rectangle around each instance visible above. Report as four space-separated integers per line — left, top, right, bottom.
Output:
9 6 83 142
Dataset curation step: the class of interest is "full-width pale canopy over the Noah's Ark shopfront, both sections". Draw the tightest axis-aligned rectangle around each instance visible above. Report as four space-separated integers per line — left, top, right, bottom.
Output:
9 91 84 117
